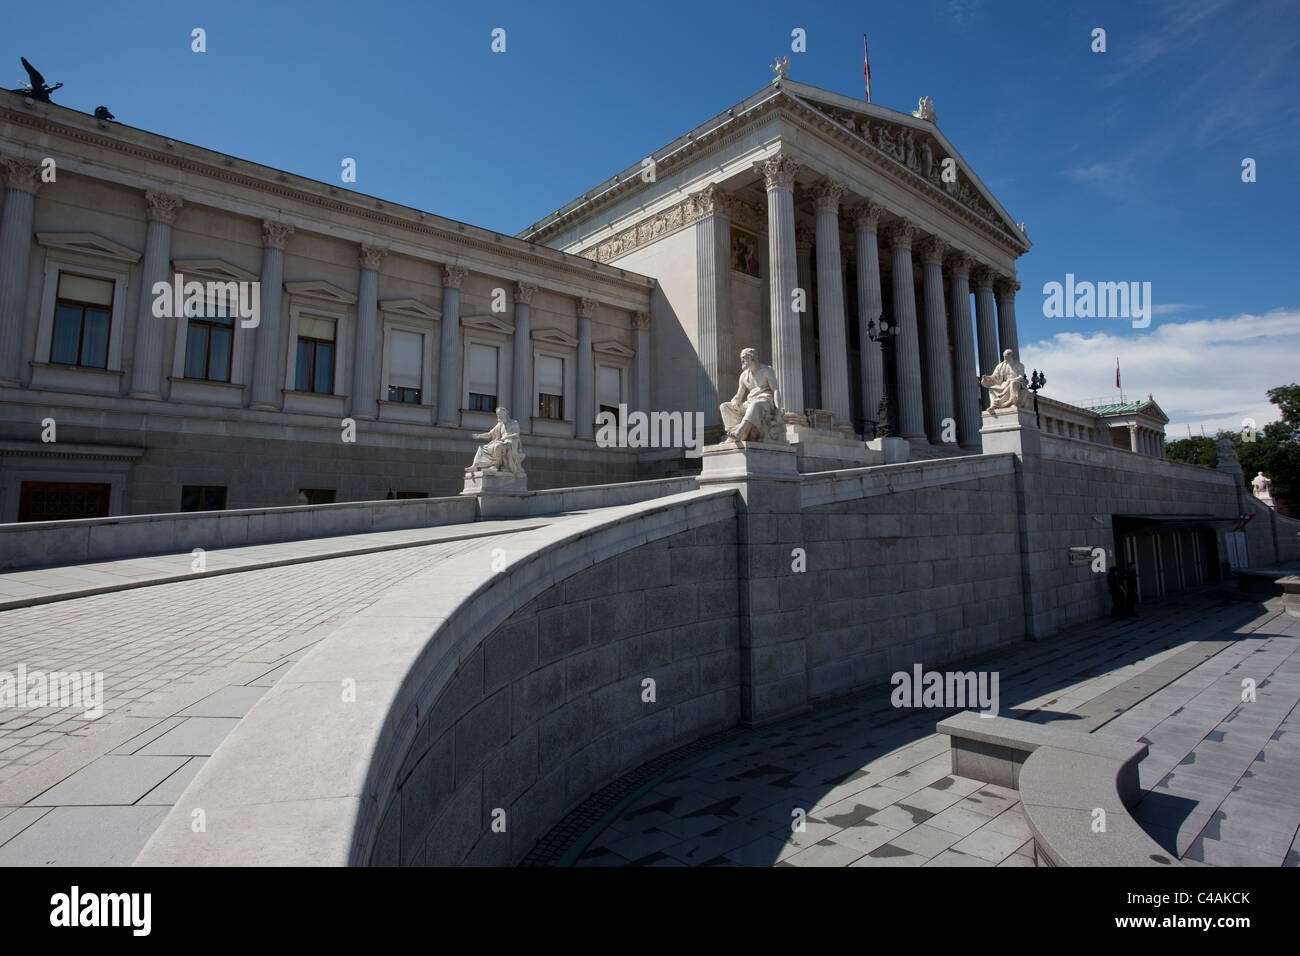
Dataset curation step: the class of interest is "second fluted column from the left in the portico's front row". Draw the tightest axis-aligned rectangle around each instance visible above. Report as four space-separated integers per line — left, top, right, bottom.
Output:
813 182 853 427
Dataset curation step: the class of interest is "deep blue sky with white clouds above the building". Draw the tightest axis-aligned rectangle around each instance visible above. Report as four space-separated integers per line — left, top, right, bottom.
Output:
0 0 1300 437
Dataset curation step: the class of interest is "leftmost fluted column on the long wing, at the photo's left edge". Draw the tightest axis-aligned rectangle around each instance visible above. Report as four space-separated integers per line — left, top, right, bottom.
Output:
0 156 42 385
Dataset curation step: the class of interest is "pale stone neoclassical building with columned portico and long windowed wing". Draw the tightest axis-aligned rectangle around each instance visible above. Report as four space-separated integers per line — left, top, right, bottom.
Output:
0 75 1138 522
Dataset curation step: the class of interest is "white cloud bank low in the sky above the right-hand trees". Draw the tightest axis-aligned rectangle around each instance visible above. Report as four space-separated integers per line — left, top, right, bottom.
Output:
1021 308 1300 441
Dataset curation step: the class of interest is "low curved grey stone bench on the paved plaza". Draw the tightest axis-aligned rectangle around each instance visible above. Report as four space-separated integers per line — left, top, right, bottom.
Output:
936 710 1182 866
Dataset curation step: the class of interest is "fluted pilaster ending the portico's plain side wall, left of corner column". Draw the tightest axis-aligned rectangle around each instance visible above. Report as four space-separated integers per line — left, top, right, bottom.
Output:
694 185 733 425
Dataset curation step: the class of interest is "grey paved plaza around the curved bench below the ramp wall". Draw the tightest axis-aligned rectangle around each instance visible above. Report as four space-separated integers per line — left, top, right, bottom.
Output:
564 592 1300 866
